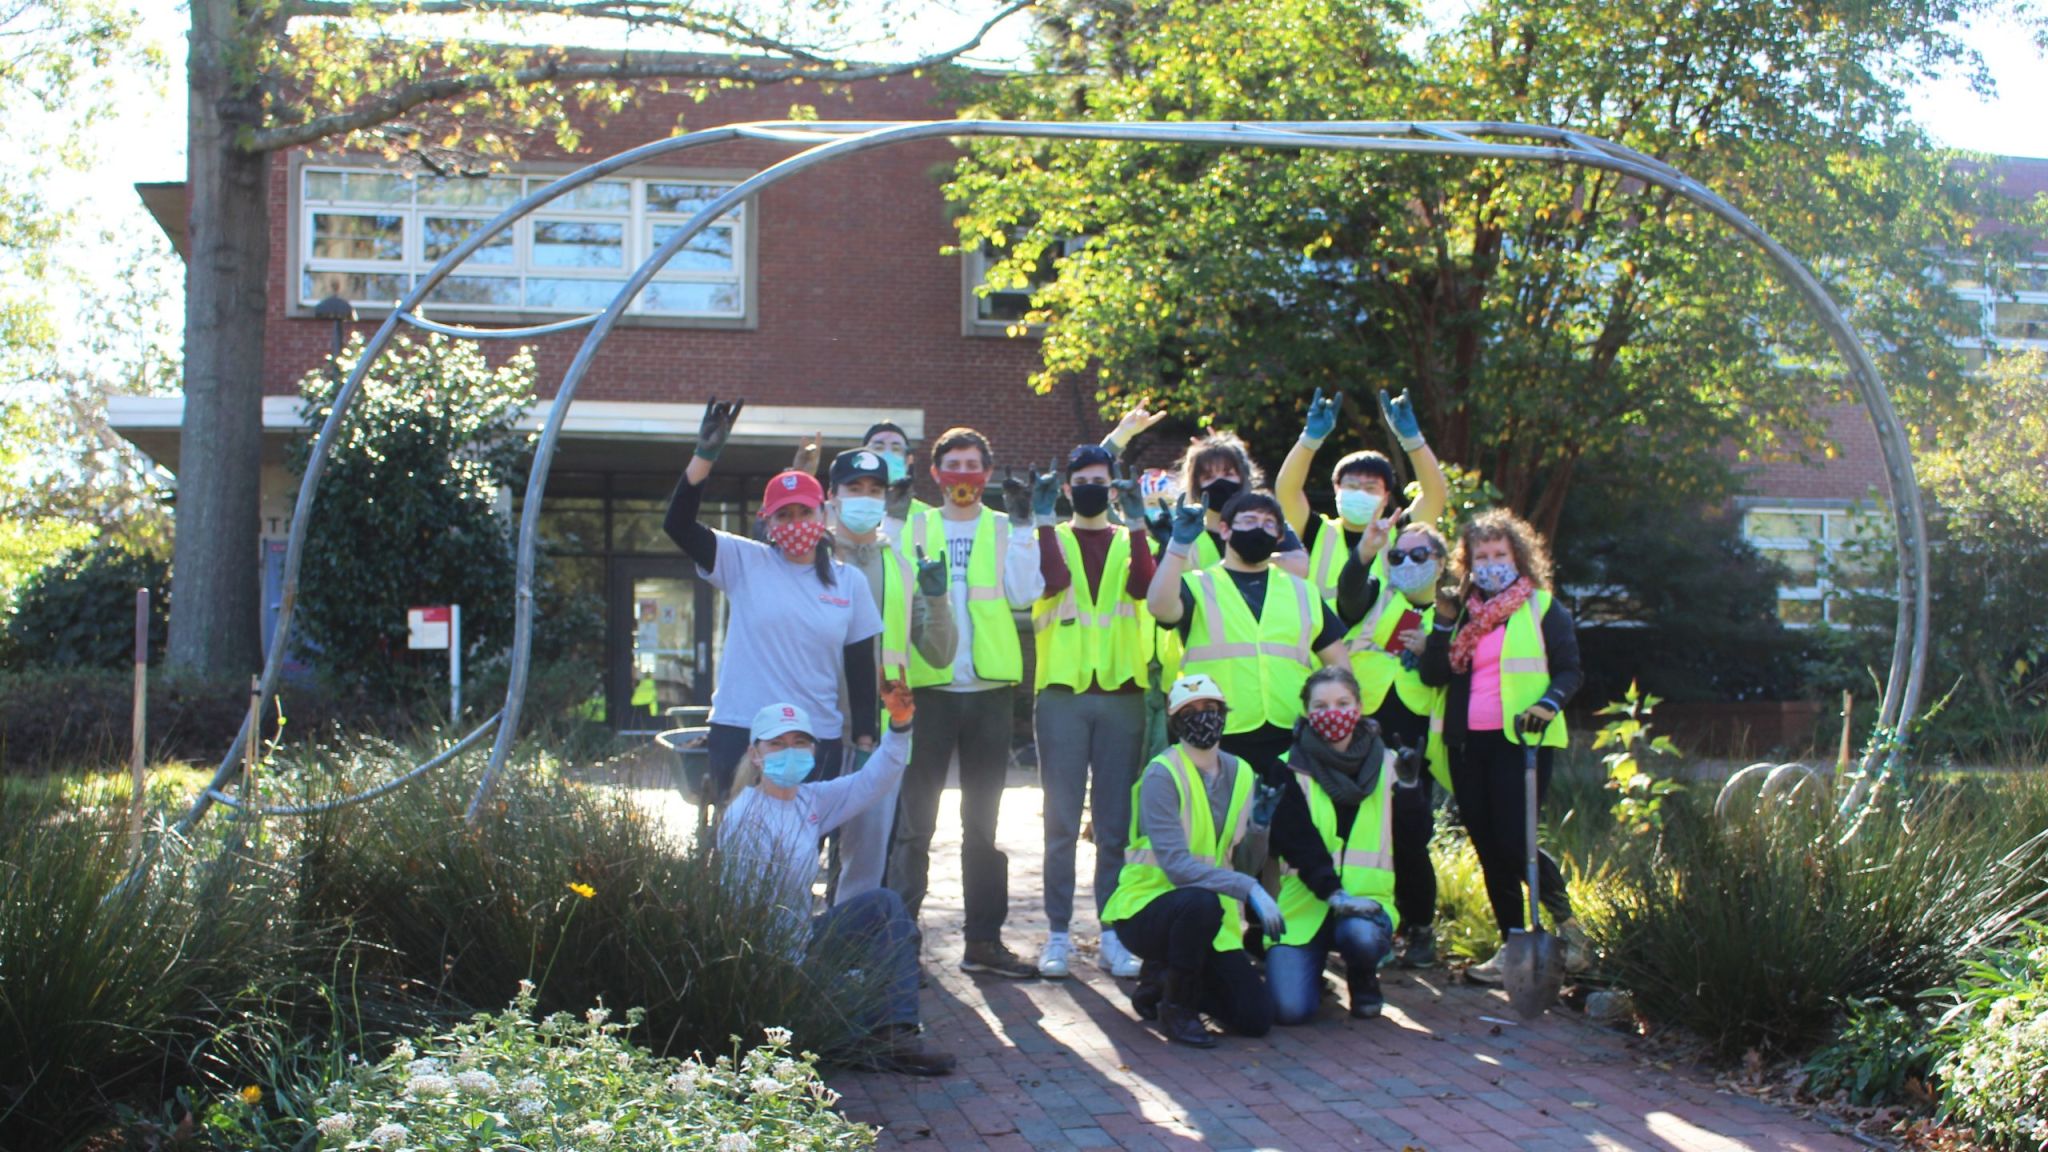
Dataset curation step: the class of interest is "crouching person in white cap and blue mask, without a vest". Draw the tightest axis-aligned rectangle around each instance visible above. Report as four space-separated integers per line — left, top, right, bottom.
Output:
719 683 954 1076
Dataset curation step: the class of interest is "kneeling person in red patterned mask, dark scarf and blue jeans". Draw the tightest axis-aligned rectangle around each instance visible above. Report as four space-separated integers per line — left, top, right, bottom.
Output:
1266 668 1395 1025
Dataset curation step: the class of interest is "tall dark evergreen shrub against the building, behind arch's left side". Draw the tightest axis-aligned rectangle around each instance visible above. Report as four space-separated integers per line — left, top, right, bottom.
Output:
291 336 535 703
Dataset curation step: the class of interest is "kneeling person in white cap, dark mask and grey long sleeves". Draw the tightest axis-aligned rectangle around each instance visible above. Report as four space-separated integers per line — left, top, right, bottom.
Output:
1102 674 1286 1047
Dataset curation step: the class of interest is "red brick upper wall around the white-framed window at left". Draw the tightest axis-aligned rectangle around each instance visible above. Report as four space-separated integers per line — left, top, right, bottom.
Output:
264 80 1102 465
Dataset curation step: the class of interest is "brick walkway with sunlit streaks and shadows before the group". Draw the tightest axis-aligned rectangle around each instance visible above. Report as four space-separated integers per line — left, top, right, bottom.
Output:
815 773 1858 1152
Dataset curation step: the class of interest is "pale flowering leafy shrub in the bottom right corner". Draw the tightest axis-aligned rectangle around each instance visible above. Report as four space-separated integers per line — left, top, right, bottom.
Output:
1935 922 2048 1148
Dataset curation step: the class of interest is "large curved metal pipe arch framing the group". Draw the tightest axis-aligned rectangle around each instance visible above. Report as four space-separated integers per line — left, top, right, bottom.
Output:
178 121 1927 830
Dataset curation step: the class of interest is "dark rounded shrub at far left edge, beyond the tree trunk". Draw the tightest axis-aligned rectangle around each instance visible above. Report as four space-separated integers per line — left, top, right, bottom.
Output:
6 543 170 668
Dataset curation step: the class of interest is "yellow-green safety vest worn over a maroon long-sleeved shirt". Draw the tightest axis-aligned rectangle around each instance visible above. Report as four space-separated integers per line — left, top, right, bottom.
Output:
1030 525 1143 693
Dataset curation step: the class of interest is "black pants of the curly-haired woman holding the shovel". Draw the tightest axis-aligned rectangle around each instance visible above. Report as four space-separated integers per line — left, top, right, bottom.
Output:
1450 732 1571 937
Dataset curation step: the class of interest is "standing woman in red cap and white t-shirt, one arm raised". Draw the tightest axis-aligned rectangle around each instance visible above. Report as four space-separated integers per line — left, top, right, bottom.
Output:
662 398 883 799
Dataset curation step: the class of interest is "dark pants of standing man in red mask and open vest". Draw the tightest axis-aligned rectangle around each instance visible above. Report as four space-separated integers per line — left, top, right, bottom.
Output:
885 685 1012 941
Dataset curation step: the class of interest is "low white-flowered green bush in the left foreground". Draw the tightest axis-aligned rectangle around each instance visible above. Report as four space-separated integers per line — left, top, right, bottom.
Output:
303 986 874 1152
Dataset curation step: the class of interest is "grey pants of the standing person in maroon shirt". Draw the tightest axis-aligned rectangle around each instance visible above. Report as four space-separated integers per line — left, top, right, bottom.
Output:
1032 687 1145 933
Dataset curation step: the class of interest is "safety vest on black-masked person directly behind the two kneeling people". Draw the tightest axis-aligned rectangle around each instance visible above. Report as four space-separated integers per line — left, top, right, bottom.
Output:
1182 564 1323 734
